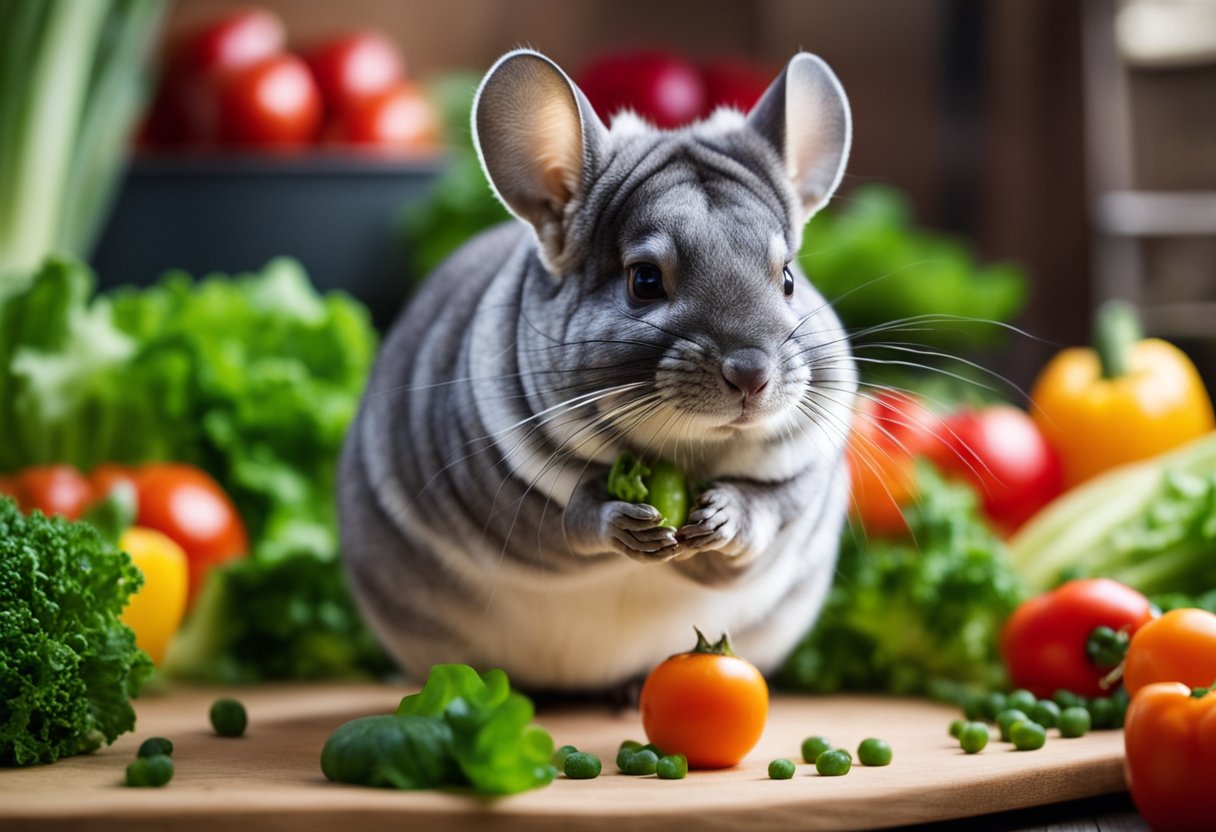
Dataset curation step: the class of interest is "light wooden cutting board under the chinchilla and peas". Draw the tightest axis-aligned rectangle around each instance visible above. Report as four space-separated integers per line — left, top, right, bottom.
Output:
0 685 1124 832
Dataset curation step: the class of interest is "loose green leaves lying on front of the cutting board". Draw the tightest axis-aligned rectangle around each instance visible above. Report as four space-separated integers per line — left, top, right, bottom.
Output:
321 664 556 794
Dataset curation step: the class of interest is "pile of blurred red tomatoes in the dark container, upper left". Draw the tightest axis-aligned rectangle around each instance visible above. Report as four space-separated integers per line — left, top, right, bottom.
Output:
141 9 440 150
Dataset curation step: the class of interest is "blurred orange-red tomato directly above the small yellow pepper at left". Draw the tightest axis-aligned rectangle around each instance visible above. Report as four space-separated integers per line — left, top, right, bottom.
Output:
135 462 248 601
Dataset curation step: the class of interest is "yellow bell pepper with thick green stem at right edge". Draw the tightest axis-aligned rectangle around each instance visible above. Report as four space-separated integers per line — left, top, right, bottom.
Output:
1030 302 1216 488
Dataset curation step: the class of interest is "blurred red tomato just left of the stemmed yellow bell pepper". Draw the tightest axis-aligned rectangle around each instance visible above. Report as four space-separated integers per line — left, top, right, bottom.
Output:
931 405 1064 532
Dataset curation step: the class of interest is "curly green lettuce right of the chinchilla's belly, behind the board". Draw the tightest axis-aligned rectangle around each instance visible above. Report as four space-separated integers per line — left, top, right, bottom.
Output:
781 466 1025 698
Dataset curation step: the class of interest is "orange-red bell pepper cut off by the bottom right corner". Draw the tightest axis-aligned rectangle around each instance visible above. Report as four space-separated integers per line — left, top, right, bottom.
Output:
1124 682 1216 832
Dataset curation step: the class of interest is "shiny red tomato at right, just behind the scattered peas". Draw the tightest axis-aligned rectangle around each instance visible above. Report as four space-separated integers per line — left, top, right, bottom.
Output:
1001 578 1153 697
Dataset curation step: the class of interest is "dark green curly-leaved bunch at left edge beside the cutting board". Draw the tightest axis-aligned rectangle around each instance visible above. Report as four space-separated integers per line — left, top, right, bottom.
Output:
0 497 152 766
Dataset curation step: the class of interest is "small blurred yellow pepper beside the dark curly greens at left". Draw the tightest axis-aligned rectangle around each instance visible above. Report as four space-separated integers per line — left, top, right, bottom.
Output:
118 525 187 664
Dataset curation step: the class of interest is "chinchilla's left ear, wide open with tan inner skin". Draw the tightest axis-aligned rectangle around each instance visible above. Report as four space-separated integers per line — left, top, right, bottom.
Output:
473 49 607 274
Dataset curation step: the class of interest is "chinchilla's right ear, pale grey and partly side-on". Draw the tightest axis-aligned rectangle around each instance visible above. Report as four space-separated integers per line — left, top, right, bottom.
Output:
748 52 852 220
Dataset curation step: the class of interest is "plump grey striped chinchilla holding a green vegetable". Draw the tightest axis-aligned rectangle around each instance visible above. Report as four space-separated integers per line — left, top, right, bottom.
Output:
339 50 856 691
